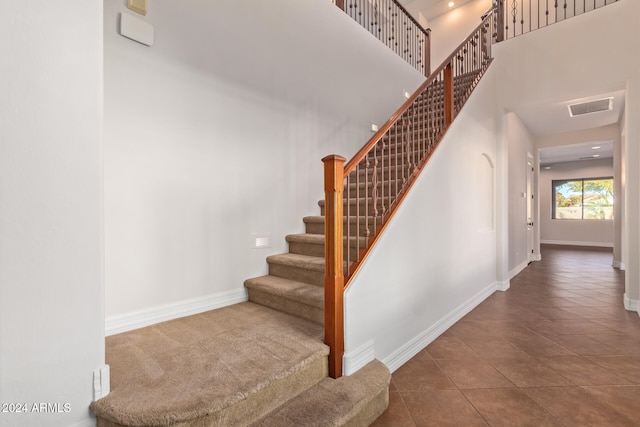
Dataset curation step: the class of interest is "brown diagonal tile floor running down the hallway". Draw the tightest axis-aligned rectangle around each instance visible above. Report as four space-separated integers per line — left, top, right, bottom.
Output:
373 246 640 427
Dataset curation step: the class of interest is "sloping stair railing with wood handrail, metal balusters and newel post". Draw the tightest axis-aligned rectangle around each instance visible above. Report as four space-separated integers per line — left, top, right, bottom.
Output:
323 12 494 377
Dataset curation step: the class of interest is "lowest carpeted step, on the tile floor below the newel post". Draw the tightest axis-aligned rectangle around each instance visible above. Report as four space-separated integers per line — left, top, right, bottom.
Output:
251 360 391 427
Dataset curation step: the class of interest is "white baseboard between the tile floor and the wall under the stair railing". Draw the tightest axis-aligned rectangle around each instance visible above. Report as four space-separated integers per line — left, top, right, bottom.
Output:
382 283 497 372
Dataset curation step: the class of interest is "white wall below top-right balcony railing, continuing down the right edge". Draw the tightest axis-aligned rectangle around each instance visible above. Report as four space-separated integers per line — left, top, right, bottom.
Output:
493 1 640 310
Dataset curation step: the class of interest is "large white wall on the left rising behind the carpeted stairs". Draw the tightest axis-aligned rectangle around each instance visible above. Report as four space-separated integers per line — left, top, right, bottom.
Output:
104 0 424 323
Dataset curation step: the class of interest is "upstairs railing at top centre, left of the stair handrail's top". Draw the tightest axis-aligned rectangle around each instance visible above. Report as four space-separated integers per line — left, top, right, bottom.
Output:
332 0 431 76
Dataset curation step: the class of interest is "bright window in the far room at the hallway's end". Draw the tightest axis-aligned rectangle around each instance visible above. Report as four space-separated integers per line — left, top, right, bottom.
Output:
551 177 613 220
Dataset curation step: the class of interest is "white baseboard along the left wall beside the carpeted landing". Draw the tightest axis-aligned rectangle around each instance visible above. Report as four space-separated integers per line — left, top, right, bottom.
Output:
105 287 249 336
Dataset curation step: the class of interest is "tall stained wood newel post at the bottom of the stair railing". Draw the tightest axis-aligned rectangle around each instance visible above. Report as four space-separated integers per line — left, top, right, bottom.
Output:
322 154 346 378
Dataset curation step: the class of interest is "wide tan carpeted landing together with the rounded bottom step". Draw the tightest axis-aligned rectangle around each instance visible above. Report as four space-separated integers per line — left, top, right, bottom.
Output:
91 302 390 427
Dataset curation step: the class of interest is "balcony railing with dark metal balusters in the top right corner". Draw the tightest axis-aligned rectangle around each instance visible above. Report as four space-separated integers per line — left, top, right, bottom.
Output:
494 0 620 42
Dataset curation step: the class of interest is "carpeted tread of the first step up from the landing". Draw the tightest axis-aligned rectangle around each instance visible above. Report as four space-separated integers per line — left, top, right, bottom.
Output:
244 276 324 309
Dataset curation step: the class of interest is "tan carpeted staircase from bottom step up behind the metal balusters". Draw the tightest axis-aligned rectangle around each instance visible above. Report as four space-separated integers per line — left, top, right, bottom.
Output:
91 5 490 427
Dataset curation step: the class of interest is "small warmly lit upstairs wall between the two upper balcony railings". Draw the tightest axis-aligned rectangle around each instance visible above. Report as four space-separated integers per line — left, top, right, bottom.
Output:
427 0 491 70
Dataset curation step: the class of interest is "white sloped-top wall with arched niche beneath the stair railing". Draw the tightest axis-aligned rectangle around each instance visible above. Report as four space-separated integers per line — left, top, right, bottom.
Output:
345 64 497 373
